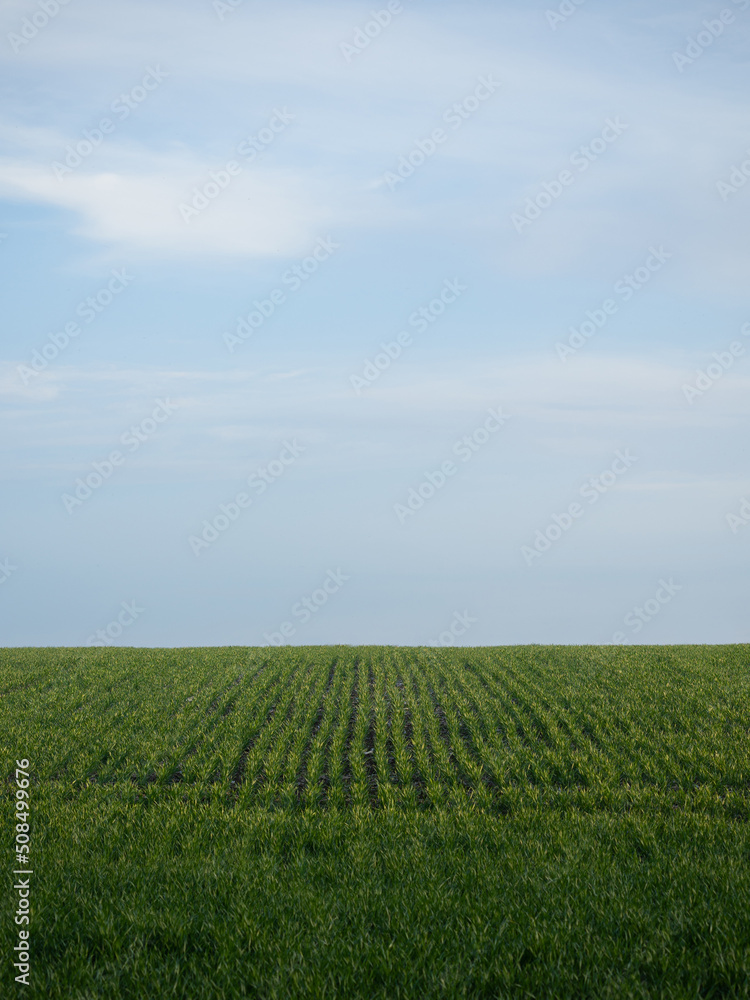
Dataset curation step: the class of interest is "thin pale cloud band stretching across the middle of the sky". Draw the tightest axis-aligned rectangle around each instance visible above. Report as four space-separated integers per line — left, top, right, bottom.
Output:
0 356 750 450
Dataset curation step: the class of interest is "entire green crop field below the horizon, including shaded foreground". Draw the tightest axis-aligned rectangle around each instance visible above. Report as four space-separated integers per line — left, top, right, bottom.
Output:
0 645 750 1000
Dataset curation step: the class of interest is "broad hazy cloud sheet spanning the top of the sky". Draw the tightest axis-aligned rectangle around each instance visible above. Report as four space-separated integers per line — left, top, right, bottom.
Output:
0 0 749 282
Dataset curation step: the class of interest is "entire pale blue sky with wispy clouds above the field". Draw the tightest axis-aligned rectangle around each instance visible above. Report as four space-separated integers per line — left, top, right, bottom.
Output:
0 0 750 647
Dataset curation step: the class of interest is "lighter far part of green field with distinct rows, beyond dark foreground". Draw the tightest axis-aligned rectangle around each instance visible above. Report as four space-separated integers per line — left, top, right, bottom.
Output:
0 646 750 808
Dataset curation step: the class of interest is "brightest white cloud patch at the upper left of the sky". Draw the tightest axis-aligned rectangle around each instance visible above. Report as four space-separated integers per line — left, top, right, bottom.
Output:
0 151 333 257
